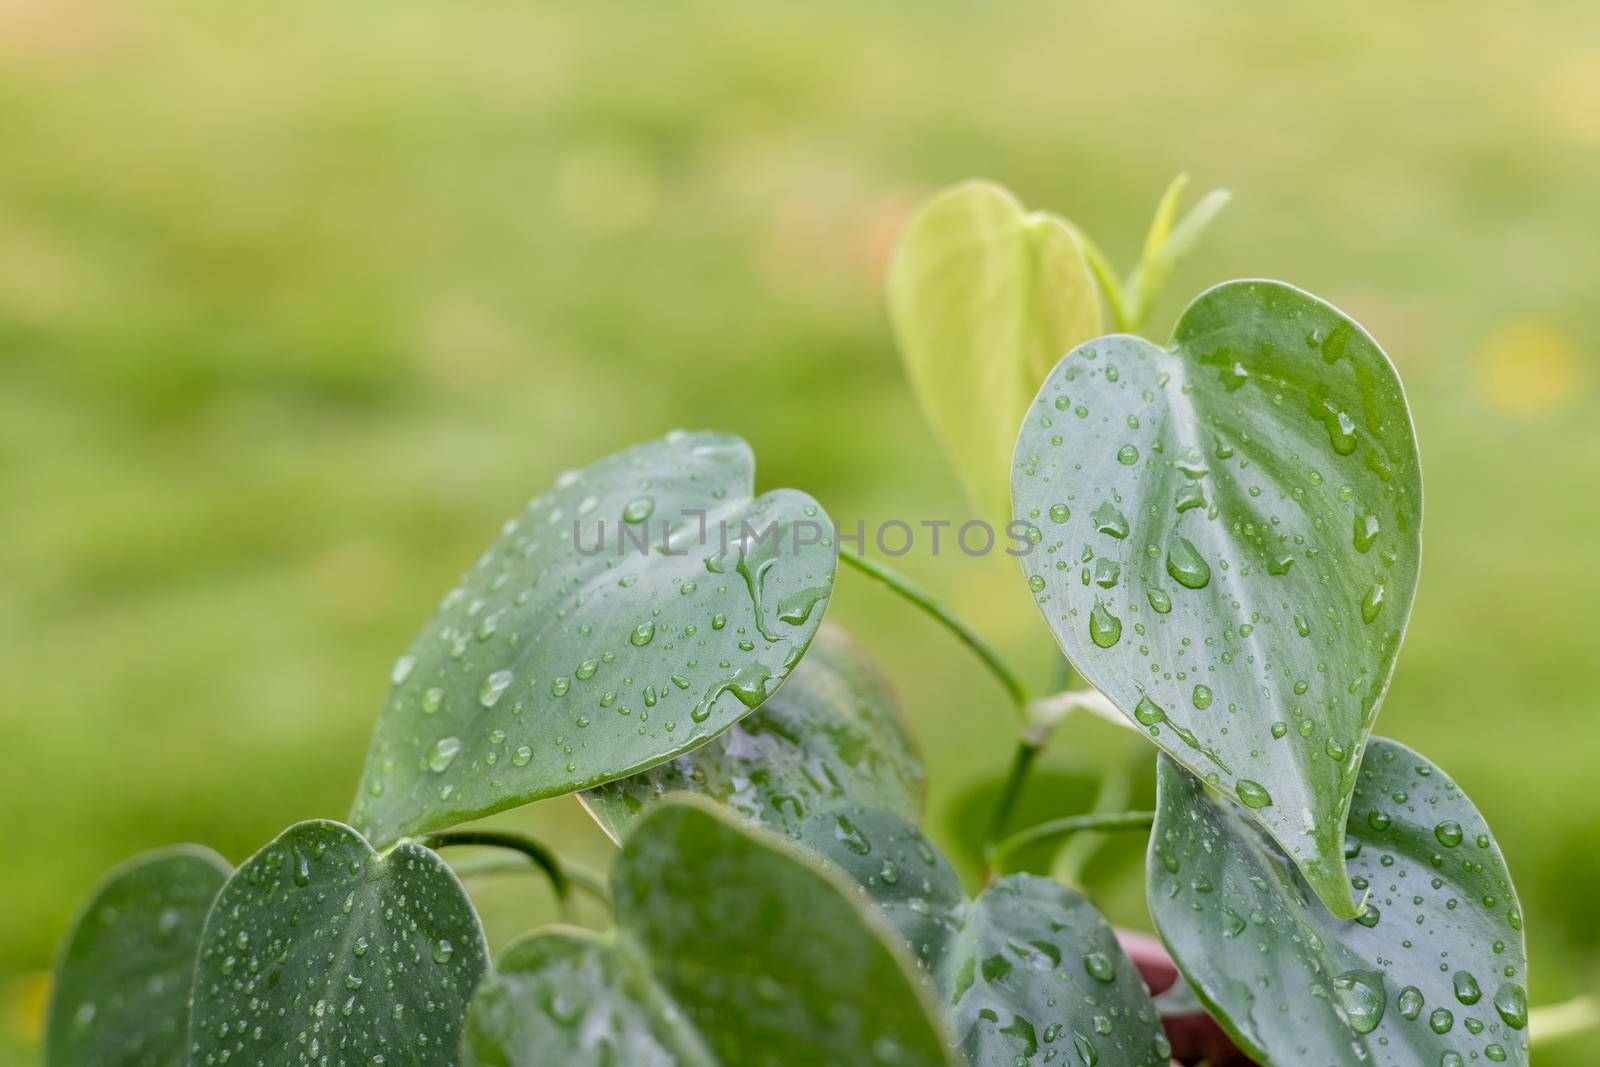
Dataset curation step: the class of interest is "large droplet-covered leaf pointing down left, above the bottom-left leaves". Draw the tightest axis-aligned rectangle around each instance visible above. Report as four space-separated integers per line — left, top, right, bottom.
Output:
352 434 837 845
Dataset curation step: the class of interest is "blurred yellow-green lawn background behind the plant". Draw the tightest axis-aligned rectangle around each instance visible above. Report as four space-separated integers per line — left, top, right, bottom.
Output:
0 0 1600 1065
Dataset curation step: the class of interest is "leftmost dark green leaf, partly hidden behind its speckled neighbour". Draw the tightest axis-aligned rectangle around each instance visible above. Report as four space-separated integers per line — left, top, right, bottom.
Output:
45 845 230 1067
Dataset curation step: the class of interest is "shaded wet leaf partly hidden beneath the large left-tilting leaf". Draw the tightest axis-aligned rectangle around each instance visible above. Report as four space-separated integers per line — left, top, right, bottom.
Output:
581 625 925 840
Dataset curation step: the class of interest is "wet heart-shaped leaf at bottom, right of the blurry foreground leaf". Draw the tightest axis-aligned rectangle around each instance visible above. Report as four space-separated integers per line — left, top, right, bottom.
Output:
802 806 1171 1067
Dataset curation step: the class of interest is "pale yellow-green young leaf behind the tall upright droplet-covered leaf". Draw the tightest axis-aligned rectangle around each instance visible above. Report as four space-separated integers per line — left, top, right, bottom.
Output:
888 182 1101 517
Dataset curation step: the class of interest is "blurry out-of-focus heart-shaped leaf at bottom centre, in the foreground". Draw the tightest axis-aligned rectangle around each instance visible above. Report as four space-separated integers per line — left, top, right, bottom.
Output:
464 795 954 1067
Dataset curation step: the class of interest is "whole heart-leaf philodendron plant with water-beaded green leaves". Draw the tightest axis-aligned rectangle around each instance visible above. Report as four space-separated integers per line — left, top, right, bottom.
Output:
46 182 1530 1067
